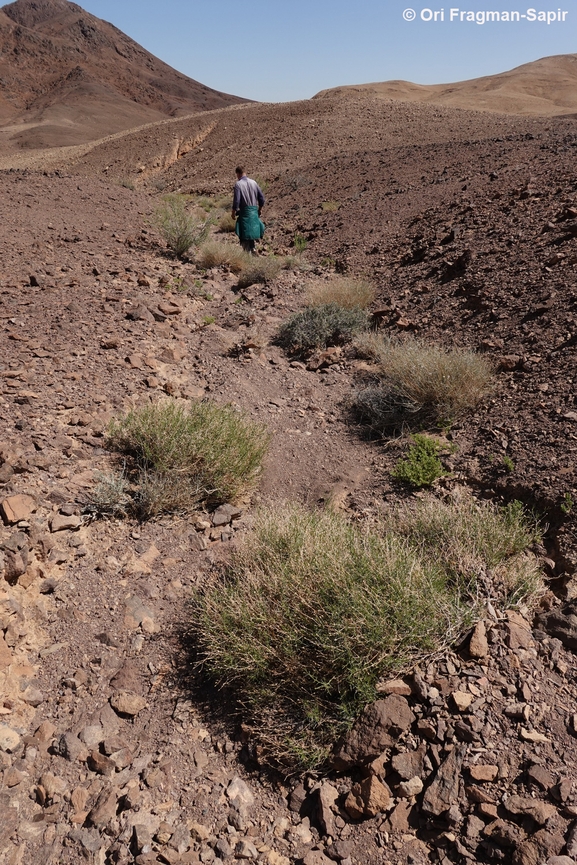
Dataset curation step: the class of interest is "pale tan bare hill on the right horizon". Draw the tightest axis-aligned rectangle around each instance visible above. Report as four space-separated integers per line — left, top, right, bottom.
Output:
316 54 577 115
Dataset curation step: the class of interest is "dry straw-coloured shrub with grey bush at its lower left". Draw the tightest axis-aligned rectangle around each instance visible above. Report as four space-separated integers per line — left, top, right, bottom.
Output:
356 334 492 430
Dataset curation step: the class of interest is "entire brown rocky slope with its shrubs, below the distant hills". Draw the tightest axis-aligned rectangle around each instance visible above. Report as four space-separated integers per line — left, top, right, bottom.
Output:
0 30 577 865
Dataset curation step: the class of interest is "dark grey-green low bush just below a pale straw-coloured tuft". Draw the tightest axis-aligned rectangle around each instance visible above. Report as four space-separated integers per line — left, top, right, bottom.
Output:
278 303 368 352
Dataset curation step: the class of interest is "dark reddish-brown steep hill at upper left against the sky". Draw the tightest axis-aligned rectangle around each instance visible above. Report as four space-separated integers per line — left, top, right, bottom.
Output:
0 0 244 147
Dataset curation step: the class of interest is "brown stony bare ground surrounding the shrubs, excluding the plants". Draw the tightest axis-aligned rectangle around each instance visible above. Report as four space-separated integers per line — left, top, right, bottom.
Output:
0 88 577 865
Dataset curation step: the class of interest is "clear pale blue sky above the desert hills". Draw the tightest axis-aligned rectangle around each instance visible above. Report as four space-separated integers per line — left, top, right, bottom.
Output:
79 0 577 102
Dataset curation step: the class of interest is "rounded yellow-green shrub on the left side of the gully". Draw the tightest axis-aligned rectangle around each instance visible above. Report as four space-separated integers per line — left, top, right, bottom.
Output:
108 400 269 517
